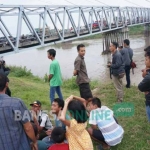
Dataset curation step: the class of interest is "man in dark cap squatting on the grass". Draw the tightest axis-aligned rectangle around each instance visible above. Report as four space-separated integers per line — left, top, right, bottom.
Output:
30 100 53 140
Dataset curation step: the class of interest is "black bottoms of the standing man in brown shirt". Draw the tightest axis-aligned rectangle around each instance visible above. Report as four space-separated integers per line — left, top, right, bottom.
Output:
79 83 93 100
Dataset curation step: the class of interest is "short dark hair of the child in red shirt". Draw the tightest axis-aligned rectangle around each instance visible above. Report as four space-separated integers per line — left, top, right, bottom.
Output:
51 127 66 143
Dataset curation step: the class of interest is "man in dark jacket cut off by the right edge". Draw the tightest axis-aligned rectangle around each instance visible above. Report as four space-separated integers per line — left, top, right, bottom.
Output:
138 46 150 122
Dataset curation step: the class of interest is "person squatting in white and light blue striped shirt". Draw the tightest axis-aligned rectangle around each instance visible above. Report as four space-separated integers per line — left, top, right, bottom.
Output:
88 97 124 149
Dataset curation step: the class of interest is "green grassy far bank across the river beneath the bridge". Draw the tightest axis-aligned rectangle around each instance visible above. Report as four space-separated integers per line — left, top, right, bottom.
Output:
81 25 144 40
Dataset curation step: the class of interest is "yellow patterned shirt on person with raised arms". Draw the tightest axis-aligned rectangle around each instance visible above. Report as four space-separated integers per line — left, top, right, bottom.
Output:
66 119 93 150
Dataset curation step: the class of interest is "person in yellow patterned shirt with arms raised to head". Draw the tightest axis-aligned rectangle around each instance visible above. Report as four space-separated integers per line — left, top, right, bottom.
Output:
59 96 93 150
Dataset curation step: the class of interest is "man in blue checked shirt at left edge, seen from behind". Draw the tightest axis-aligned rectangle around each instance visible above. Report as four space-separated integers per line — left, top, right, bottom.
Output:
0 73 38 150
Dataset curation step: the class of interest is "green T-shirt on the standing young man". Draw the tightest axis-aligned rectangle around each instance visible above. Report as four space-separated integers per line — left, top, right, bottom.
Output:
50 59 62 86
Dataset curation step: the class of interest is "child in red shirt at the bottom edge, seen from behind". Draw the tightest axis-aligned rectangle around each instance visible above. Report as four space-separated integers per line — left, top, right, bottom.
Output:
48 127 69 150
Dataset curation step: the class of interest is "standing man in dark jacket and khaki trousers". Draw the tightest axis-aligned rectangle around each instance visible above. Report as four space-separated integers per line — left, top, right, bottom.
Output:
108 42 125 102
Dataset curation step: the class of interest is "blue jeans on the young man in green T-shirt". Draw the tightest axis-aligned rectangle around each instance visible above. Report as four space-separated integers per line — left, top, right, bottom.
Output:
50 86 63 104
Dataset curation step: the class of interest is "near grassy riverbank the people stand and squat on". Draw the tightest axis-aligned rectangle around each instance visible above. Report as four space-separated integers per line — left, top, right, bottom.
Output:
9 67 150 150
